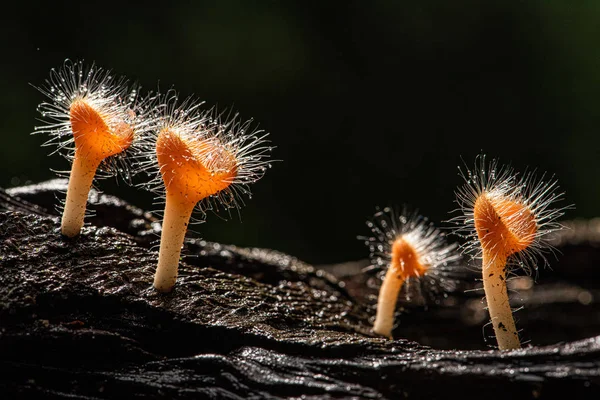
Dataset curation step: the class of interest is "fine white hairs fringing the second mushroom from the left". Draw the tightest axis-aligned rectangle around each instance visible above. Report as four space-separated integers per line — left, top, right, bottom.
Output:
136 89 274 222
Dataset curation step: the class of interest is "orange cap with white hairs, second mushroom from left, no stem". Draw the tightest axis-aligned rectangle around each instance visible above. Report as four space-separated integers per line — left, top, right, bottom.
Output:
137 90 274 216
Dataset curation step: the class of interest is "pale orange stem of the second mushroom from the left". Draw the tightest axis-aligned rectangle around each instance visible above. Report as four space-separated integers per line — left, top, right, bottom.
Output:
154 191 196 293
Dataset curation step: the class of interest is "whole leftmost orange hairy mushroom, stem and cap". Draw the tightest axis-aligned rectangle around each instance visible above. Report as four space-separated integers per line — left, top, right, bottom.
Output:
36 61 150 237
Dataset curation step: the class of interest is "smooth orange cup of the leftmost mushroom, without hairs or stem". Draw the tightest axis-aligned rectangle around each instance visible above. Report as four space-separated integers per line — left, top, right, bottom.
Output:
69 100 133 160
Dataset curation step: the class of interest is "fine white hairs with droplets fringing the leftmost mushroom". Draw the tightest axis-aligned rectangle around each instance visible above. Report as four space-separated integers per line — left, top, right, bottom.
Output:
33 59 155 183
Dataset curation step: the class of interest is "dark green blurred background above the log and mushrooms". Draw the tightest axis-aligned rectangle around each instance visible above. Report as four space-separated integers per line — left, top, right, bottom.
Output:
0 0 600 264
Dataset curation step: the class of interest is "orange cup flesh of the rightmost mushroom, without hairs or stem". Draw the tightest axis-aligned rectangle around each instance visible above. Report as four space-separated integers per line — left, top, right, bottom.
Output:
473 193 537 257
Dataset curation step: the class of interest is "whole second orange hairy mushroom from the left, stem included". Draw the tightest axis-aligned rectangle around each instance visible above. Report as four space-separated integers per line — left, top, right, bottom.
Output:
139 92 272 292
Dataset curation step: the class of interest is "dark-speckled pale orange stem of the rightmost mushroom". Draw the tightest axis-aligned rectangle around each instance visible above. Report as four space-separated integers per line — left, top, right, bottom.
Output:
483 250 521 350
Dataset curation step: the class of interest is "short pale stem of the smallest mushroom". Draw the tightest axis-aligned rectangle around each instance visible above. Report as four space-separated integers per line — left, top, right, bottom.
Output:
373 265 404 339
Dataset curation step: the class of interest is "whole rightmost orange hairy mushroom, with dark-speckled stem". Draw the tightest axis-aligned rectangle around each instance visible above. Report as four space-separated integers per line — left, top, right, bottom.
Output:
455 156 565 350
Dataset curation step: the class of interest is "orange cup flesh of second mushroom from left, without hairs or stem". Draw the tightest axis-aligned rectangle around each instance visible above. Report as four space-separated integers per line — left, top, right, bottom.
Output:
156 128 237 203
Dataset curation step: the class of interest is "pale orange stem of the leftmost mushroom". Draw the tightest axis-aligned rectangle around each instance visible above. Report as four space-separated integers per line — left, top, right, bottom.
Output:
61 152 101 237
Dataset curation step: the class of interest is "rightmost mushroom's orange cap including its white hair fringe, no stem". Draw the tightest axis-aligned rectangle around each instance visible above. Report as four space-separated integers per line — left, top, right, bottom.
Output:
451 155 571 273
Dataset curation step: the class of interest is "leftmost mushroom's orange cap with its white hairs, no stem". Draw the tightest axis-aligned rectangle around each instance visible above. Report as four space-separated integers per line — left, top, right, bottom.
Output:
34 60 154 180
